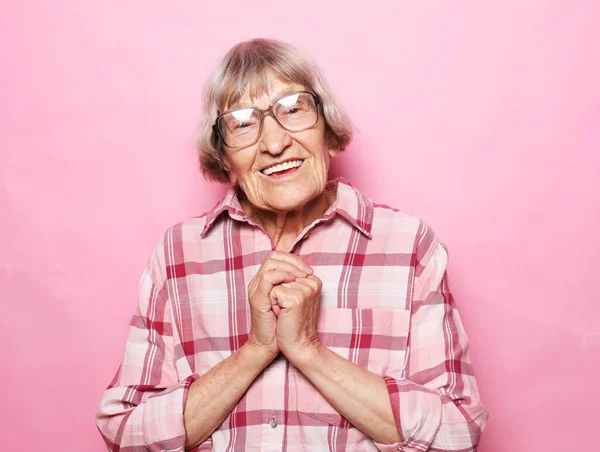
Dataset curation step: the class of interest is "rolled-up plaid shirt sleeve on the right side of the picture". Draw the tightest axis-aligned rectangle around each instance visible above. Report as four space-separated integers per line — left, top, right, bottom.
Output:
375 223 488 452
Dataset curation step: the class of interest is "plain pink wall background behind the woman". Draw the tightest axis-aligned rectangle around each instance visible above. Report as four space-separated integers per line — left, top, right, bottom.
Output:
0 0 600 452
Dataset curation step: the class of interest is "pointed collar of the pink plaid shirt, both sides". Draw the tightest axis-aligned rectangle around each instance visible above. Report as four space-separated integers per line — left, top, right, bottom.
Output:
200 178 373 239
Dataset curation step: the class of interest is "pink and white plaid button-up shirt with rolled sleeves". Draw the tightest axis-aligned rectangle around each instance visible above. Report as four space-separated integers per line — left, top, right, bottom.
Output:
97 180 488 452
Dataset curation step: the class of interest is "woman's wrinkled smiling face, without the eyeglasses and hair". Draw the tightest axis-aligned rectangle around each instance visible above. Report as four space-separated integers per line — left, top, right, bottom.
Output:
223 73 339 212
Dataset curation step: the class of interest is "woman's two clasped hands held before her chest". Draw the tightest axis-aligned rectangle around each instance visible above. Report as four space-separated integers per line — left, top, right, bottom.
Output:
248 251 322 364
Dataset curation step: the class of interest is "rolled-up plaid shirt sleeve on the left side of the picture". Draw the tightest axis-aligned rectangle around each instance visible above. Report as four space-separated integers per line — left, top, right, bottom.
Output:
96 238 198 452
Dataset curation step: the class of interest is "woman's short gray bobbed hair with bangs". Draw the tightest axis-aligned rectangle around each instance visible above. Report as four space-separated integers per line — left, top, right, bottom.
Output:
196 39 352 183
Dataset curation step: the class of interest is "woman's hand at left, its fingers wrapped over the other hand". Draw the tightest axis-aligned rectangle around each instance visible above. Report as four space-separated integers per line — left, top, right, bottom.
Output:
248 251 313 357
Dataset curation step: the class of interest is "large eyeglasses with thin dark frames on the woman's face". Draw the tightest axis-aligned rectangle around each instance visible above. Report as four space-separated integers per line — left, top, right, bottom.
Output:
213 91 321 148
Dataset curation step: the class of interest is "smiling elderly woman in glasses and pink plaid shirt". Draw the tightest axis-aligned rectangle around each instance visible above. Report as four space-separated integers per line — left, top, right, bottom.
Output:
97 39 487 451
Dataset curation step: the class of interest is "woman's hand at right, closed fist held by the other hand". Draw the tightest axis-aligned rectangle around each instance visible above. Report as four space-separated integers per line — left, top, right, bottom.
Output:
270 275 322 364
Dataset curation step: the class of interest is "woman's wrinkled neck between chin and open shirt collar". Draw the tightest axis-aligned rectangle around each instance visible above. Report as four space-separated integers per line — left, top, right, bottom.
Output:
240 189 336 251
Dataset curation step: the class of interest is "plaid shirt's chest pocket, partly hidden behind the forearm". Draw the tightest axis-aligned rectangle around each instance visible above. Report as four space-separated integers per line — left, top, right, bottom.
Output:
289 308 410 428
